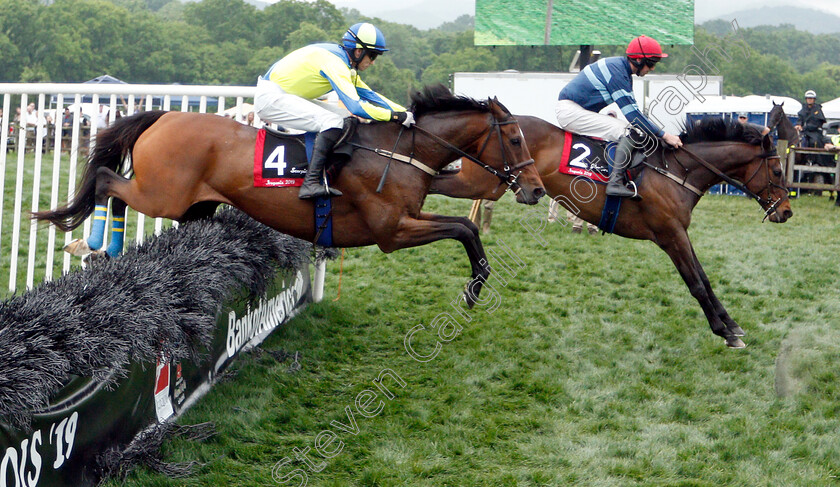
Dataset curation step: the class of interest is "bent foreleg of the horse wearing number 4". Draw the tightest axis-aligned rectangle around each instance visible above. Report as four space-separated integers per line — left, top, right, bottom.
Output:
378 212 490 308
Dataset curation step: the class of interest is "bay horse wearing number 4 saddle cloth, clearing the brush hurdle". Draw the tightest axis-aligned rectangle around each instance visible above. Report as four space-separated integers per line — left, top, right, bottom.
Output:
33 89 545 306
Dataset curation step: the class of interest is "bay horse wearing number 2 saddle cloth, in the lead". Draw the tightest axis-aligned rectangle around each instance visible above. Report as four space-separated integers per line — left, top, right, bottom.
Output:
431 116 793 348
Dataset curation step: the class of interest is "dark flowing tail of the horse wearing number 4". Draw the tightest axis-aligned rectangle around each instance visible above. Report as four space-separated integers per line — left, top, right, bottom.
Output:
32 110 166 232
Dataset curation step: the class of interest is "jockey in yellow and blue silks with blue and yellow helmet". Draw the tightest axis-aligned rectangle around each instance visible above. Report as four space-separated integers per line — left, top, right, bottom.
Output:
254 23 414 198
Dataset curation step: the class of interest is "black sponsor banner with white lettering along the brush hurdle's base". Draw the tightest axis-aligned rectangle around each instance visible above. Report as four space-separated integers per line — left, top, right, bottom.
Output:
0 265 312 487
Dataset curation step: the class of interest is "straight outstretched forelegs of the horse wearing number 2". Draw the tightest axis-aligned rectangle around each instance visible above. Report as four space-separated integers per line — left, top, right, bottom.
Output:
657 228 746 348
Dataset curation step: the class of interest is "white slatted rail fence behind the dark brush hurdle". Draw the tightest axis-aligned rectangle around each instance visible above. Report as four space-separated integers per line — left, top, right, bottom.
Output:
0 83 323 296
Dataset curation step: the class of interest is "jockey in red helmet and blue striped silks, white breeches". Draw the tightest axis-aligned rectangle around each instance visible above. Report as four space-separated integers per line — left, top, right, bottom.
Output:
555 36 682 198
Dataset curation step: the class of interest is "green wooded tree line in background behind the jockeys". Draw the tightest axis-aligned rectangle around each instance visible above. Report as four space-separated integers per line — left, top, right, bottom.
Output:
0 0 840 103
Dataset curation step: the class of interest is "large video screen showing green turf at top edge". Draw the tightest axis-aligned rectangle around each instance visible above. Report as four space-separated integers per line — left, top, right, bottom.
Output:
475 0 694 46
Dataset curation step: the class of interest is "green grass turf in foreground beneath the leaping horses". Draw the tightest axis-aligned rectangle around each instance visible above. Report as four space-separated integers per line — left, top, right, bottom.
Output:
103 195 840 486
